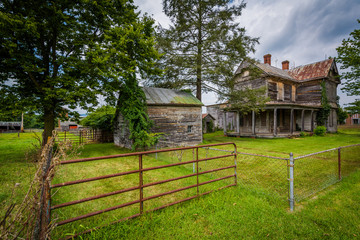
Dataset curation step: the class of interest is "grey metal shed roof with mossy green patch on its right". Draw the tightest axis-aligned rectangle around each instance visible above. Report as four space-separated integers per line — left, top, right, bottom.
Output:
143 87 204 106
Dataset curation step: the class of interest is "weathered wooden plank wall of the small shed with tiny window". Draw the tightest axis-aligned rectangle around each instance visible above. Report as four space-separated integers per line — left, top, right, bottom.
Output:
148 106 202 147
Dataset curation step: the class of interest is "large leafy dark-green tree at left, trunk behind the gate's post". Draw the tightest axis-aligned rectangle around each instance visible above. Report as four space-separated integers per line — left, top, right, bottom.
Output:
0 0 157 143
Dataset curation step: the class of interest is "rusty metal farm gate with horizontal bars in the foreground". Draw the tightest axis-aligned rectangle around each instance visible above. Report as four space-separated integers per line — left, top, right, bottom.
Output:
47 143 237 238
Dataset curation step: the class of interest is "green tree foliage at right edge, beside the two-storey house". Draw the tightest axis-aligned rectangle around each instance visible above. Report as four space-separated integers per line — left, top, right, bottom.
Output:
336 19 360 96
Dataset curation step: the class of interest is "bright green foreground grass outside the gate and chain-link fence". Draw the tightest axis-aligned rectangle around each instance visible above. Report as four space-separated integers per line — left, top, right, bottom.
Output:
79 172 360 239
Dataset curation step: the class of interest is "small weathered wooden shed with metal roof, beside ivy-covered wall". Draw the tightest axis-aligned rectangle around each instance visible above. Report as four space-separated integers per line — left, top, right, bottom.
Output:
114 87 203 148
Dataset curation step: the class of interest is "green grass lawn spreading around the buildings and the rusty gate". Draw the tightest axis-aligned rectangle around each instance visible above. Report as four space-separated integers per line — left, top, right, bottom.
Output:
0 128 360 239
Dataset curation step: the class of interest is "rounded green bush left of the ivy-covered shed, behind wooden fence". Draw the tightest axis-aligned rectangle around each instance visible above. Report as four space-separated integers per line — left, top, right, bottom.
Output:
80 106 115 131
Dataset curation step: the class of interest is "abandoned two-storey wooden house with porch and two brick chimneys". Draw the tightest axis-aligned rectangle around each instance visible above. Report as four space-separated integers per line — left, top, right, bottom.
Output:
207 54 340 137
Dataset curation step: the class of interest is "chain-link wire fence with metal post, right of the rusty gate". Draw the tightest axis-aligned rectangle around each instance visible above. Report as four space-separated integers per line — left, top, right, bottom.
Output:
229 144 360 210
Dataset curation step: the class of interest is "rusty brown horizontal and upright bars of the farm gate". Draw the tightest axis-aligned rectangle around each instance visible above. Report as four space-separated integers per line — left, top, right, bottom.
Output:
50 143 237 238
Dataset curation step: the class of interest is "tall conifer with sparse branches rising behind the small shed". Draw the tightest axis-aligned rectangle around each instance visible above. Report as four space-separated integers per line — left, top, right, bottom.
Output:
149 0 258 100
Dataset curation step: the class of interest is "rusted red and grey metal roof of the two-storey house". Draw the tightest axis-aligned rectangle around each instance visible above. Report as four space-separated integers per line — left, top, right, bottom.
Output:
242 58 338 82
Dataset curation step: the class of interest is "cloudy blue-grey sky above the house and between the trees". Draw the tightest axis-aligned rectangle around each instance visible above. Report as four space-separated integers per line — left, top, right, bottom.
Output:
135 0 360 105
